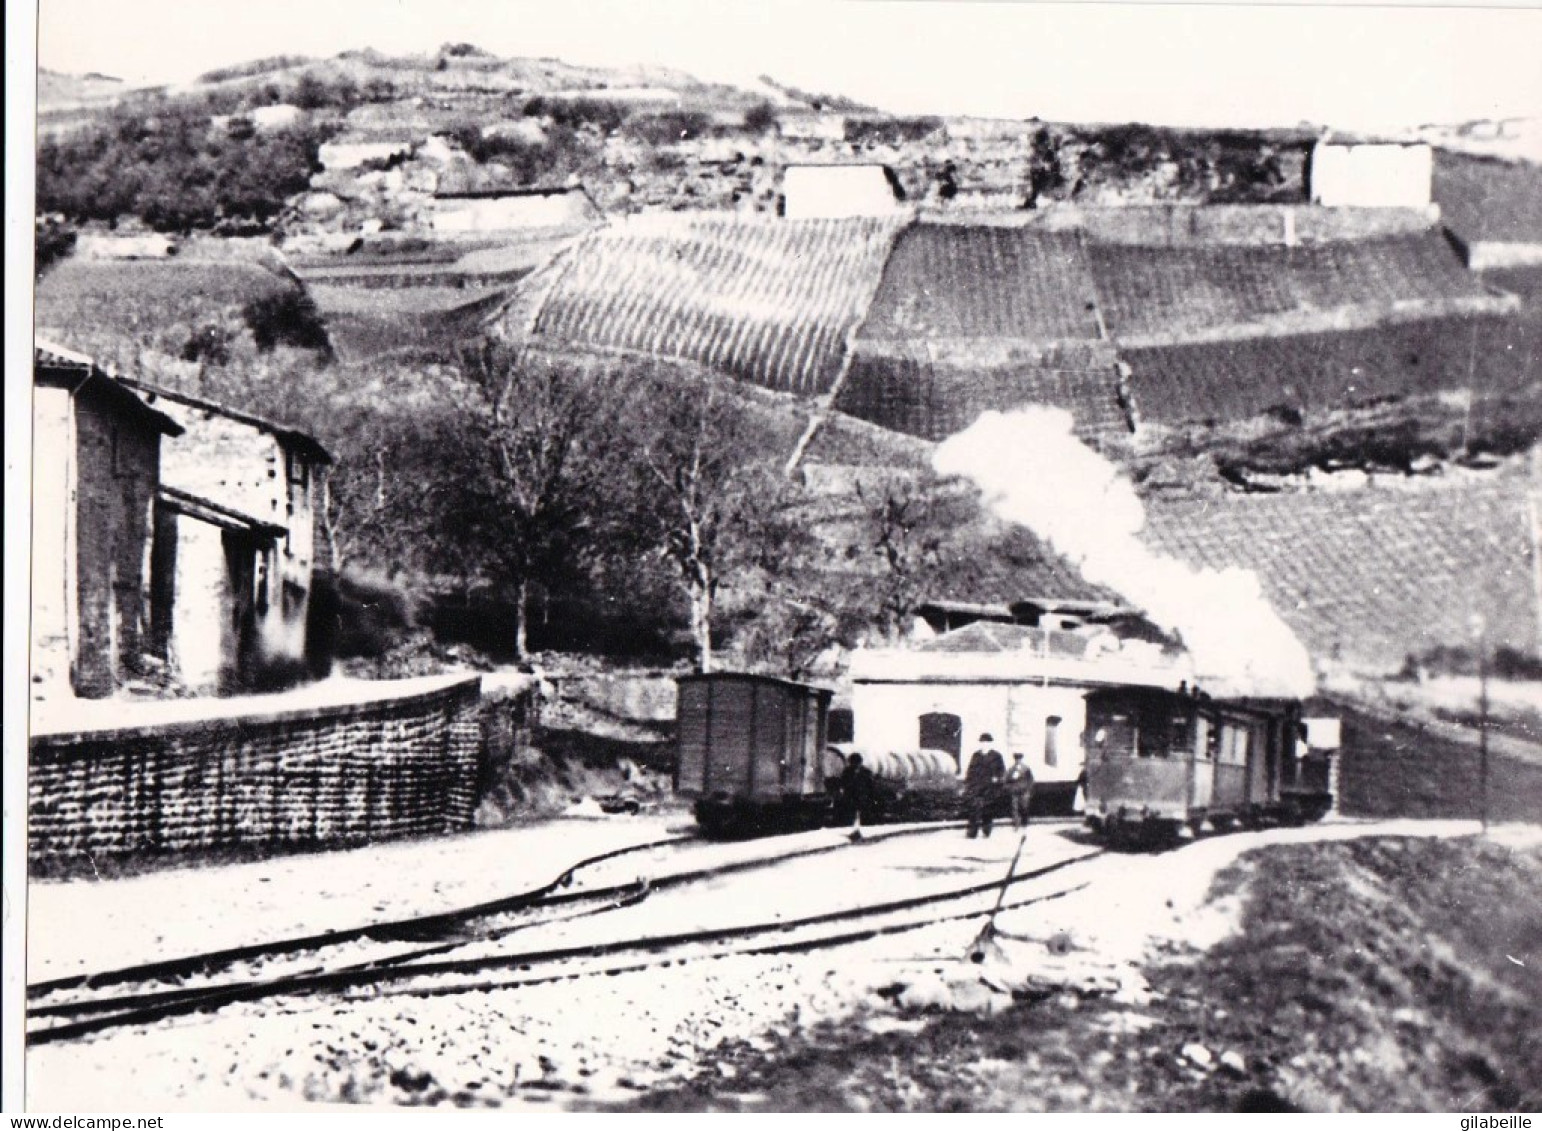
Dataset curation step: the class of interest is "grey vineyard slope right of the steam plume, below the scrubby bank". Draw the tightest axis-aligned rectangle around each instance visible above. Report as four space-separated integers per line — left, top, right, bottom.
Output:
1143 477 1542 671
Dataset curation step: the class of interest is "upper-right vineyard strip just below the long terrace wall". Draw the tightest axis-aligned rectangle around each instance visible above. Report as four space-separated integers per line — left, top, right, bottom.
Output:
1087 231 1496 346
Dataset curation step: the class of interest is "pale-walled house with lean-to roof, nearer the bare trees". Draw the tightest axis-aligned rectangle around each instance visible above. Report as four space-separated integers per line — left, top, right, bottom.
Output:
123 378 332 694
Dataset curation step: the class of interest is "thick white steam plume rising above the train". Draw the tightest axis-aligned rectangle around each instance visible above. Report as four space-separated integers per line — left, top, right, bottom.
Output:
931 407 1317 697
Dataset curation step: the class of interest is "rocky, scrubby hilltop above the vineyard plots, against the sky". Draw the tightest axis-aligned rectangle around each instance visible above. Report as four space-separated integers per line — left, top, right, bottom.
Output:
39 43 1350 242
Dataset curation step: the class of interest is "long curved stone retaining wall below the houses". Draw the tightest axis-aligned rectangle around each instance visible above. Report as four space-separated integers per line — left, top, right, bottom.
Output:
28 677 481 859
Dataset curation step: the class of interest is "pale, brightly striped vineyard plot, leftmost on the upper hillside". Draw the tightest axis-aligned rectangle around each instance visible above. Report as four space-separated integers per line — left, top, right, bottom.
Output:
535 214 904 393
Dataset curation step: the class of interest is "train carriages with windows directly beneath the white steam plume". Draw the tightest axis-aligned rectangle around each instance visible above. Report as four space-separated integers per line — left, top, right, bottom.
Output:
1086 687 1332 841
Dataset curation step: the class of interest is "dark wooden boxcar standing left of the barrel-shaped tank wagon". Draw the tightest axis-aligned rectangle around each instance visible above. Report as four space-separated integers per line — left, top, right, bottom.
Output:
674 673 833 835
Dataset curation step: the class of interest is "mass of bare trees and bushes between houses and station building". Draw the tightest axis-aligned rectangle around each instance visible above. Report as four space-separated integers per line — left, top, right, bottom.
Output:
183 339 1011 676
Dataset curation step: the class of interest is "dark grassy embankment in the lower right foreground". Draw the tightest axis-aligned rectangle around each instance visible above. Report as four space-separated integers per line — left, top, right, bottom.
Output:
616 838 1542 1111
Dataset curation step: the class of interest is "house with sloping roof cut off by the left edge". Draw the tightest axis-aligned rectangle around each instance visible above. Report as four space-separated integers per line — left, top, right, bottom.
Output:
31 341 182 701
